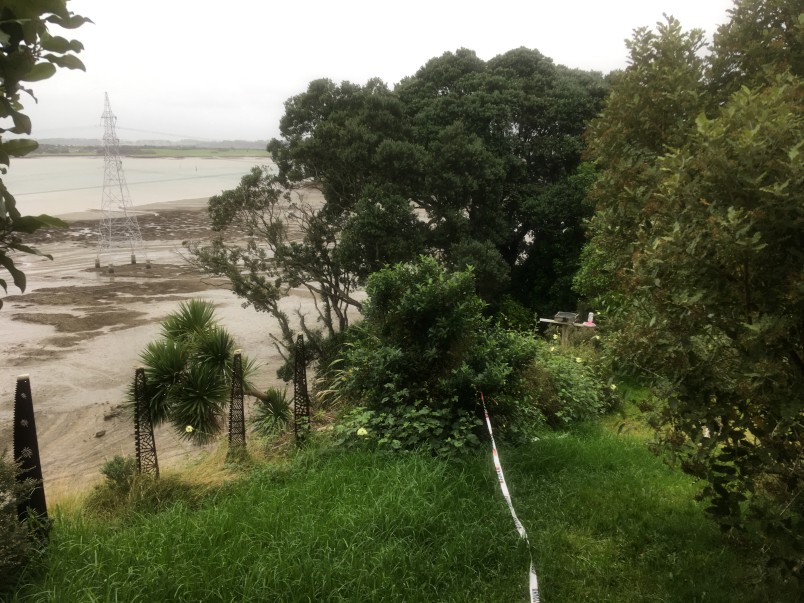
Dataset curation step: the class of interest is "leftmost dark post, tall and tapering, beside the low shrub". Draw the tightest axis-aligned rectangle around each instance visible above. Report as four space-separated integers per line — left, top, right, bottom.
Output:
14 375 48 526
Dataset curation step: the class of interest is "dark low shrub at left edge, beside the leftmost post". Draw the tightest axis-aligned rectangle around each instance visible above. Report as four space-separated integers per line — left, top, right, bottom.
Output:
0 452 37 594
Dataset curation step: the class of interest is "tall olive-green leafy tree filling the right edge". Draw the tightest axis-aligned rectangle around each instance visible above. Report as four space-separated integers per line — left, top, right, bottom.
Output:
577 0 804 575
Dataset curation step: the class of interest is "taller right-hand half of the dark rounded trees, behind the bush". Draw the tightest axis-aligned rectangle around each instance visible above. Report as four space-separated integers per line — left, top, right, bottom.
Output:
391 48 605 313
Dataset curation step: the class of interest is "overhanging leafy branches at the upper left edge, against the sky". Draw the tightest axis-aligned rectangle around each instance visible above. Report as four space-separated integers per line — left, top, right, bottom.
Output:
0 0 89 306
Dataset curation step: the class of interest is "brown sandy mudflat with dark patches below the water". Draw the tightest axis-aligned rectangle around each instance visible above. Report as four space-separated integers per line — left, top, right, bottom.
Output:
0 199 324 500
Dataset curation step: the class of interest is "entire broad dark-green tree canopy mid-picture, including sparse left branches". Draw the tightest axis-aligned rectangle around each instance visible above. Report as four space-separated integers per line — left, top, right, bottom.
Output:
195 48 606 346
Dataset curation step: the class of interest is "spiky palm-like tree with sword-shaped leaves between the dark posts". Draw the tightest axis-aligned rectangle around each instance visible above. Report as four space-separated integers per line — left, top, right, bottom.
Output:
132 299 254 444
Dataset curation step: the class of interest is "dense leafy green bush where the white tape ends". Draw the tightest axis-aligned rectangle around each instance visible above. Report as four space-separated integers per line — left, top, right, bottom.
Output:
324 257 535 452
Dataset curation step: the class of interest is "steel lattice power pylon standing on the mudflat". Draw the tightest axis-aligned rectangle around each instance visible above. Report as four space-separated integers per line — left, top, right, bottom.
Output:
95 92 150 272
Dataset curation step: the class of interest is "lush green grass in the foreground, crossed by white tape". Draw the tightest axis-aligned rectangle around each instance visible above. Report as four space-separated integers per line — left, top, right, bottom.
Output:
10 426 795 603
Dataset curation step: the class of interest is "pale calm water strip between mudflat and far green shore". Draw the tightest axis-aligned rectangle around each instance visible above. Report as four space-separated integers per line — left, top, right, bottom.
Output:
3 157 270 216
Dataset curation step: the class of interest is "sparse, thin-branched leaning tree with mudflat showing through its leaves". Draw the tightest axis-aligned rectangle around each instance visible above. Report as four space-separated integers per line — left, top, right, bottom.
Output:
185 167 361 378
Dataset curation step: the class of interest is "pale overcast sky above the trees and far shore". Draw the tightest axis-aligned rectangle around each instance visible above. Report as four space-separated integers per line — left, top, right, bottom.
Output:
26 0 732 140
